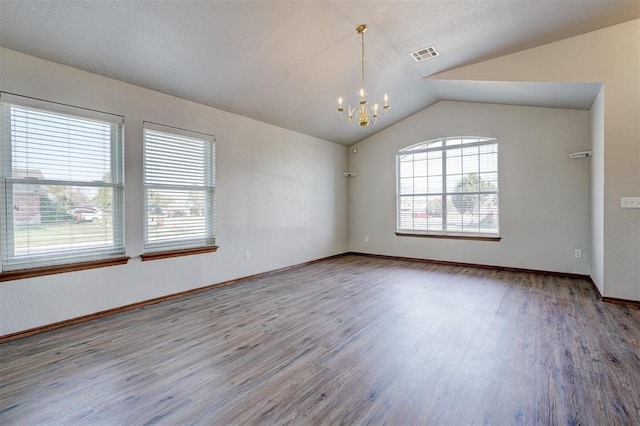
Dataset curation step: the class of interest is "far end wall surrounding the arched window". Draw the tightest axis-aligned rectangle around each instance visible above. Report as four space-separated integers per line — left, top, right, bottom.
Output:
349 102 590 274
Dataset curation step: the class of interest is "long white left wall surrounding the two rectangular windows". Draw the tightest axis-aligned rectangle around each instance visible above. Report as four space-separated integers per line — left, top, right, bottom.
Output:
0 49 348 335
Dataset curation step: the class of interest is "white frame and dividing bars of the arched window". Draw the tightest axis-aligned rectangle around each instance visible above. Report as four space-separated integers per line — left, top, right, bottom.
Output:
395 136 502 241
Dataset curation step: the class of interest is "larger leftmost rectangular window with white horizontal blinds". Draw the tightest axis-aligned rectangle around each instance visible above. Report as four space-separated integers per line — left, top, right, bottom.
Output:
0 93 124 271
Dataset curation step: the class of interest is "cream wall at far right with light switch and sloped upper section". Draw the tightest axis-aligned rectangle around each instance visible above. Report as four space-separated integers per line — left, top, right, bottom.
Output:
432 19 640 300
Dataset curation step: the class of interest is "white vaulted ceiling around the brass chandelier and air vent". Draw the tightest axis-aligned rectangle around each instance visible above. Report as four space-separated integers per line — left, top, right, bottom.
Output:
0 0 640 145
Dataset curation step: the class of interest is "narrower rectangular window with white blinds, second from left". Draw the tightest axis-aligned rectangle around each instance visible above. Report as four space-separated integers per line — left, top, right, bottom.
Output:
144 123 215 253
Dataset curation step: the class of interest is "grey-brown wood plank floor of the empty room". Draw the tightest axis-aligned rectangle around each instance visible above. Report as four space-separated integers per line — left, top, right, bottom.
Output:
0 256 640 425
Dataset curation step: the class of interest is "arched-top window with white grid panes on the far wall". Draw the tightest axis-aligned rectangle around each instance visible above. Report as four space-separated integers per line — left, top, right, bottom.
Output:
396 137 499 236
